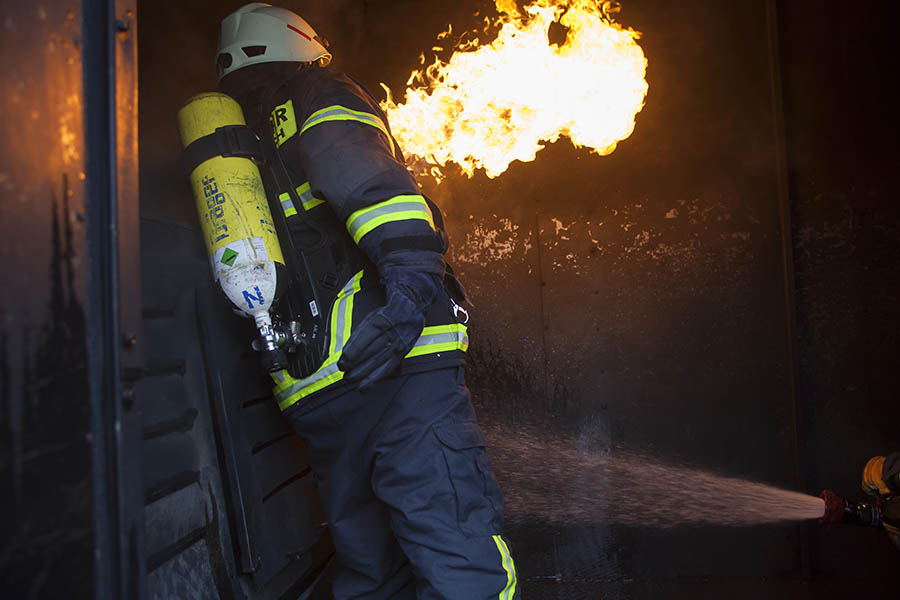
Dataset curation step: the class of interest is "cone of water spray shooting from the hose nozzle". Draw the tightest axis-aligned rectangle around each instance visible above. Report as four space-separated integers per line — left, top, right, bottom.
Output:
487 428 825 528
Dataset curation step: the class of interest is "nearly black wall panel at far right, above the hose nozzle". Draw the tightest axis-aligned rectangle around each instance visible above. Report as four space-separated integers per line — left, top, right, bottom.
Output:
780 1 900 590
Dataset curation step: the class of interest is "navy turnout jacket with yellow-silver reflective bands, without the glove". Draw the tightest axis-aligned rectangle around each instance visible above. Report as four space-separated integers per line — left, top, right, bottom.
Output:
267 67 468 412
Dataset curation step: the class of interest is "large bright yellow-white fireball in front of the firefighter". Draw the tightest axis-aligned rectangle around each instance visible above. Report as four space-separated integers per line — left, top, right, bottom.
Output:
381 0 648 179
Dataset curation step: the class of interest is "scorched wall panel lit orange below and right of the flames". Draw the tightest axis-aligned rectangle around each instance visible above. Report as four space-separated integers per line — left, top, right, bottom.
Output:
412 1 801 598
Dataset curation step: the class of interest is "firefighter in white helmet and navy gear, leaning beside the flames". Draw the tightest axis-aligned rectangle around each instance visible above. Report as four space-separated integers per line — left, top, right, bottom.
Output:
216 3 520 600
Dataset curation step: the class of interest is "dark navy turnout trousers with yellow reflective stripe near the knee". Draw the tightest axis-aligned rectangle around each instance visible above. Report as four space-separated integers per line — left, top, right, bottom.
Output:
286 366 520 600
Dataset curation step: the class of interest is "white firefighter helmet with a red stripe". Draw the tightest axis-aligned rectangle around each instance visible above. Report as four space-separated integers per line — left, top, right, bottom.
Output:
216 2 331 81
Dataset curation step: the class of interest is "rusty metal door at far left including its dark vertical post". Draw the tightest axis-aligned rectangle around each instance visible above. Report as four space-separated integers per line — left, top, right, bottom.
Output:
0 0 142 598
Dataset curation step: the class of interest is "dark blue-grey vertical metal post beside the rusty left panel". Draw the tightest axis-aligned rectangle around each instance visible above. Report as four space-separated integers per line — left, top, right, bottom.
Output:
81 0 125 598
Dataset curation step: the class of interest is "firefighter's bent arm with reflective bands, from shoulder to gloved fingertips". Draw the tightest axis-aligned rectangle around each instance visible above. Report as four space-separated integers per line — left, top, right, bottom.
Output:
300 89 446 389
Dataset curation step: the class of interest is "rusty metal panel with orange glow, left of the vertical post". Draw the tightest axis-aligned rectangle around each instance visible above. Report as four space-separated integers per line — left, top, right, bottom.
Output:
0 0 93 598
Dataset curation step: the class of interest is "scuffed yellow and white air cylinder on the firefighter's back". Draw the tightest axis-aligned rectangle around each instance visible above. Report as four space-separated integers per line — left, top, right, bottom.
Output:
178 93 284 328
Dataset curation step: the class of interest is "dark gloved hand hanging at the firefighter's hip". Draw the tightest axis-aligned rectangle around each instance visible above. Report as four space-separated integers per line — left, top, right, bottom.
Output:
338 269 441 392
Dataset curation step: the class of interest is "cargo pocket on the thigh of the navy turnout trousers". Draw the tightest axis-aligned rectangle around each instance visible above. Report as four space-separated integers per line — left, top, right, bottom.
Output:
432 423 503 537
